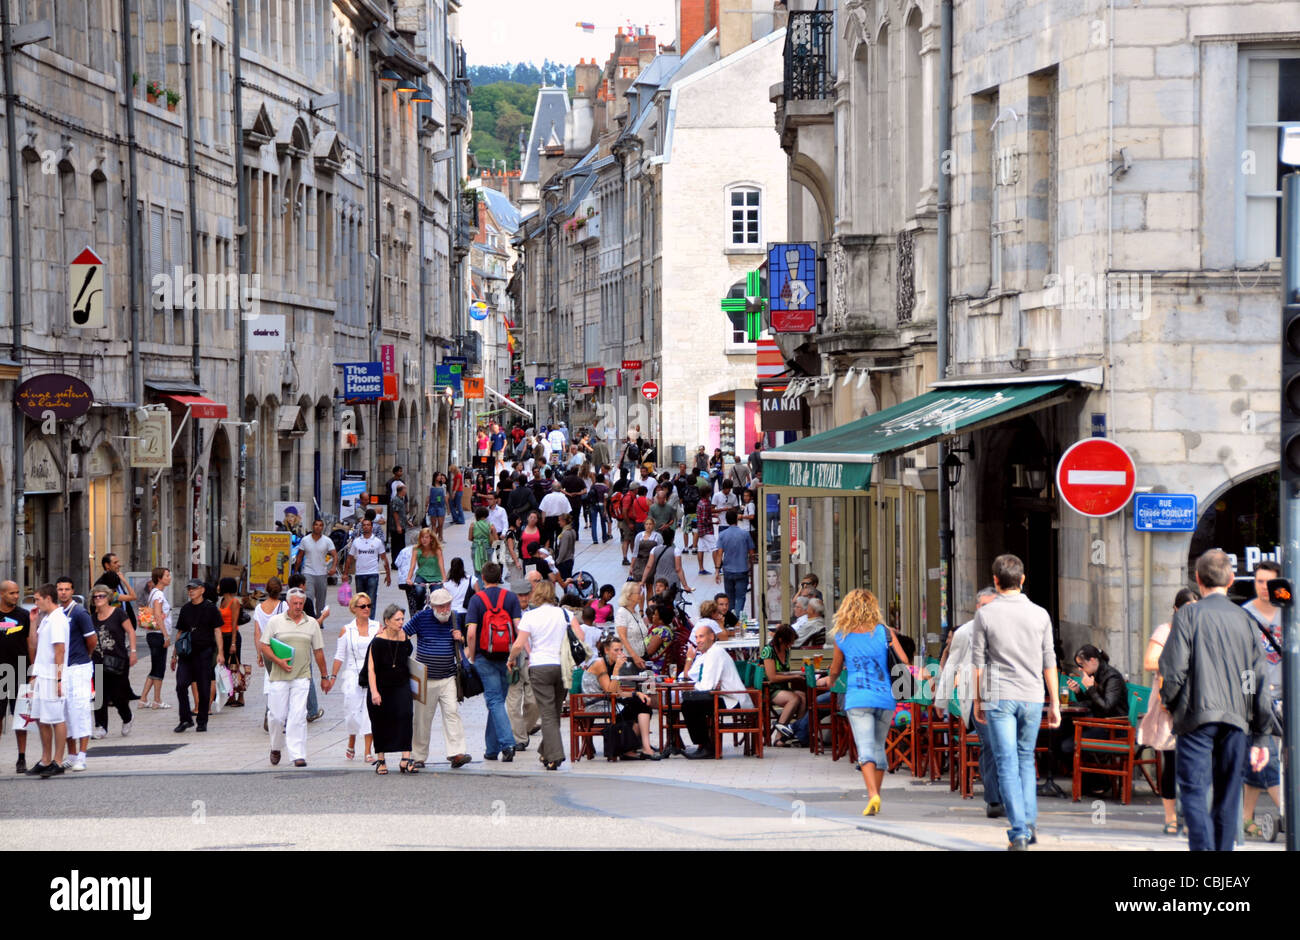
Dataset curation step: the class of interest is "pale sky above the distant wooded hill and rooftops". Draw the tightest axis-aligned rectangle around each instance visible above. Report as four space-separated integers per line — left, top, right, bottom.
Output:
460 0 676 65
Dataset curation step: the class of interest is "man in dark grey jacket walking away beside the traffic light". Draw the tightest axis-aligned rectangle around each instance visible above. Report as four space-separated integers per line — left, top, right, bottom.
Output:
1160 549 1274 852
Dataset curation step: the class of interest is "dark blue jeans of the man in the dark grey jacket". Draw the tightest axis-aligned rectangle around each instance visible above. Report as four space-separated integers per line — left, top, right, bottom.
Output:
1177 722 1251 852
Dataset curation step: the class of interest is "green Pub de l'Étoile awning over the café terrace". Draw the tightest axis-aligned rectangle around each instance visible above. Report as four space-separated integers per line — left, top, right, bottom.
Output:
763 382 1074 490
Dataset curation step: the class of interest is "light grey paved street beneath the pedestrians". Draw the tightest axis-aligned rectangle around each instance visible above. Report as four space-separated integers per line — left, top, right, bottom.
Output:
0 514 1281 850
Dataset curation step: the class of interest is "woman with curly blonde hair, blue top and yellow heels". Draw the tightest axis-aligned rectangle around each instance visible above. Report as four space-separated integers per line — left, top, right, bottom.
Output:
829 589 907 816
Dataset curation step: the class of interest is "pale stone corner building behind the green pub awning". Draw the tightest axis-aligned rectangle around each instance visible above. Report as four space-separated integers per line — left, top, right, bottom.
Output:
772 0 1300 679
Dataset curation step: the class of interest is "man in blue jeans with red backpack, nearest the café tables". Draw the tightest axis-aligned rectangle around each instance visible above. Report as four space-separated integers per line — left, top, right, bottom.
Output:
465 562 523 762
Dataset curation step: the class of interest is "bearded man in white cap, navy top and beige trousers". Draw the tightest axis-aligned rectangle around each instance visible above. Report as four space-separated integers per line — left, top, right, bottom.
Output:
403 588 469 770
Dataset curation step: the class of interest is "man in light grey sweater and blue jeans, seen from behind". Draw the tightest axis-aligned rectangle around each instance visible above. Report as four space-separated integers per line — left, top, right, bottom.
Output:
971 555 1061 852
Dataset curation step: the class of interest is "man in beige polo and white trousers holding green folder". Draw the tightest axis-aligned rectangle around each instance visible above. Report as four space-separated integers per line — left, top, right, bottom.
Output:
257 588 335 767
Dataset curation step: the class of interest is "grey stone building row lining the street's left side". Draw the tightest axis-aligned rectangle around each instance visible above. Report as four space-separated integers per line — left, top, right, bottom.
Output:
0 0 478 590
